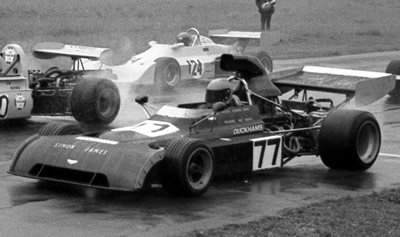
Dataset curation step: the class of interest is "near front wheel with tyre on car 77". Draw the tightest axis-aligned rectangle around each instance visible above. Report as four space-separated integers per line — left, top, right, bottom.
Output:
161 138 214 196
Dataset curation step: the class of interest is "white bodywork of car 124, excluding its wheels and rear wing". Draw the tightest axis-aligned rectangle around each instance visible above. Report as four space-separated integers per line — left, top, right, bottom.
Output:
83 36 238 84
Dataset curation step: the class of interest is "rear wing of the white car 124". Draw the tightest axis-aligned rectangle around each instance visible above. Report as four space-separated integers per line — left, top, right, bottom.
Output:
208 29 281 47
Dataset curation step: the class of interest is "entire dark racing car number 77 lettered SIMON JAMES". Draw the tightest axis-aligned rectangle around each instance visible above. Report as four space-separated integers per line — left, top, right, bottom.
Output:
9 55 394 196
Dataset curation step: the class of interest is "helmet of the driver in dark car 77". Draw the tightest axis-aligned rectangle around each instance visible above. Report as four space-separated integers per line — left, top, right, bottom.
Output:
206 78 232 105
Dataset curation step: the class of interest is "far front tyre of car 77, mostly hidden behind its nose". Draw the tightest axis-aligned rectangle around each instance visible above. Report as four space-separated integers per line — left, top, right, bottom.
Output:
39 122 83 136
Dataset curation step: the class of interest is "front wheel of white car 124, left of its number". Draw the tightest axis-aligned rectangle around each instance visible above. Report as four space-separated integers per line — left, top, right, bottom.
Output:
154 58 181 89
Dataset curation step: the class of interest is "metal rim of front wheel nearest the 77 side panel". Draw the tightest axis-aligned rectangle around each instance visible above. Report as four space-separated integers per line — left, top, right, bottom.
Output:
186 148 213 190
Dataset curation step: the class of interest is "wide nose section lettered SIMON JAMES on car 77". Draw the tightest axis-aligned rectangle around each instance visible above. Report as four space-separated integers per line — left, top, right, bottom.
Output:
9 135 163 191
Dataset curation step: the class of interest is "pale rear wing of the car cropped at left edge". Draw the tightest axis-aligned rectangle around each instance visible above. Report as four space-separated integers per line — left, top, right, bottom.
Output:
32 42 108 60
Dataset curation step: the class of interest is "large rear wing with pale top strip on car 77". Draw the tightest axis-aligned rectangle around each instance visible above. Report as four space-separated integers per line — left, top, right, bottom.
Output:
271 66 396 106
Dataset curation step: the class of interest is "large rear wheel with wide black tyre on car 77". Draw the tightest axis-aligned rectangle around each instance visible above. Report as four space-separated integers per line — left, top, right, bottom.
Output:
319 110 381 171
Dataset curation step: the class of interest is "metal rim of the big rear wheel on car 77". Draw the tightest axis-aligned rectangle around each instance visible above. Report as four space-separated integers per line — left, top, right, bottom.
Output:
357 122 380 164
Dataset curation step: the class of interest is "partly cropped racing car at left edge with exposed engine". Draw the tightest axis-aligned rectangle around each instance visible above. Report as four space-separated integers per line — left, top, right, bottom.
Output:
0 43 120 124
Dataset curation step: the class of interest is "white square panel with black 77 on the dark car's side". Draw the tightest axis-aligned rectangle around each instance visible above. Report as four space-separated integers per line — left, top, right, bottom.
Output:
251 136 282 171
